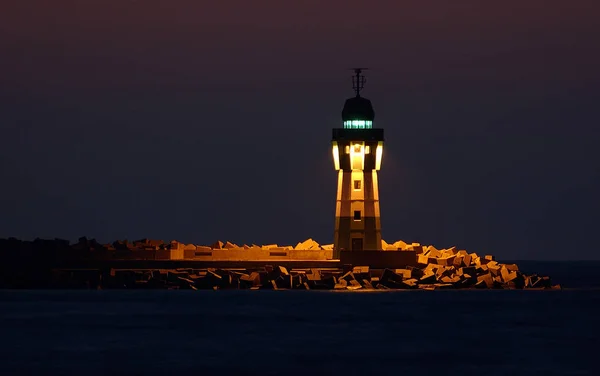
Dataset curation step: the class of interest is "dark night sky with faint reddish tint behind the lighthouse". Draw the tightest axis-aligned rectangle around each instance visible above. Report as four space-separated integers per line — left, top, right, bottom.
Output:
0 0 600 259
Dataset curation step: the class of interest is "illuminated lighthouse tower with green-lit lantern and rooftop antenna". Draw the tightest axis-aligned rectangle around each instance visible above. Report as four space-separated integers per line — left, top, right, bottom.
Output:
331 68 383 256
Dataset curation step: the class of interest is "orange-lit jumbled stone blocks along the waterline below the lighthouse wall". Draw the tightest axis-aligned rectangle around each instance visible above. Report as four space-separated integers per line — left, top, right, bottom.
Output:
79 252 560 290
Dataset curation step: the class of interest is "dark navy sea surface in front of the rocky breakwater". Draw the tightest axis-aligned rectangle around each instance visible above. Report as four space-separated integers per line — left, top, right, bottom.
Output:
0 261 600 376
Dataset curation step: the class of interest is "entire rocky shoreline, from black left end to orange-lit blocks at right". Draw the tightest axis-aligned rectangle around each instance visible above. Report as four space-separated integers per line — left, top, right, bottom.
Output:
0 238 561 290
